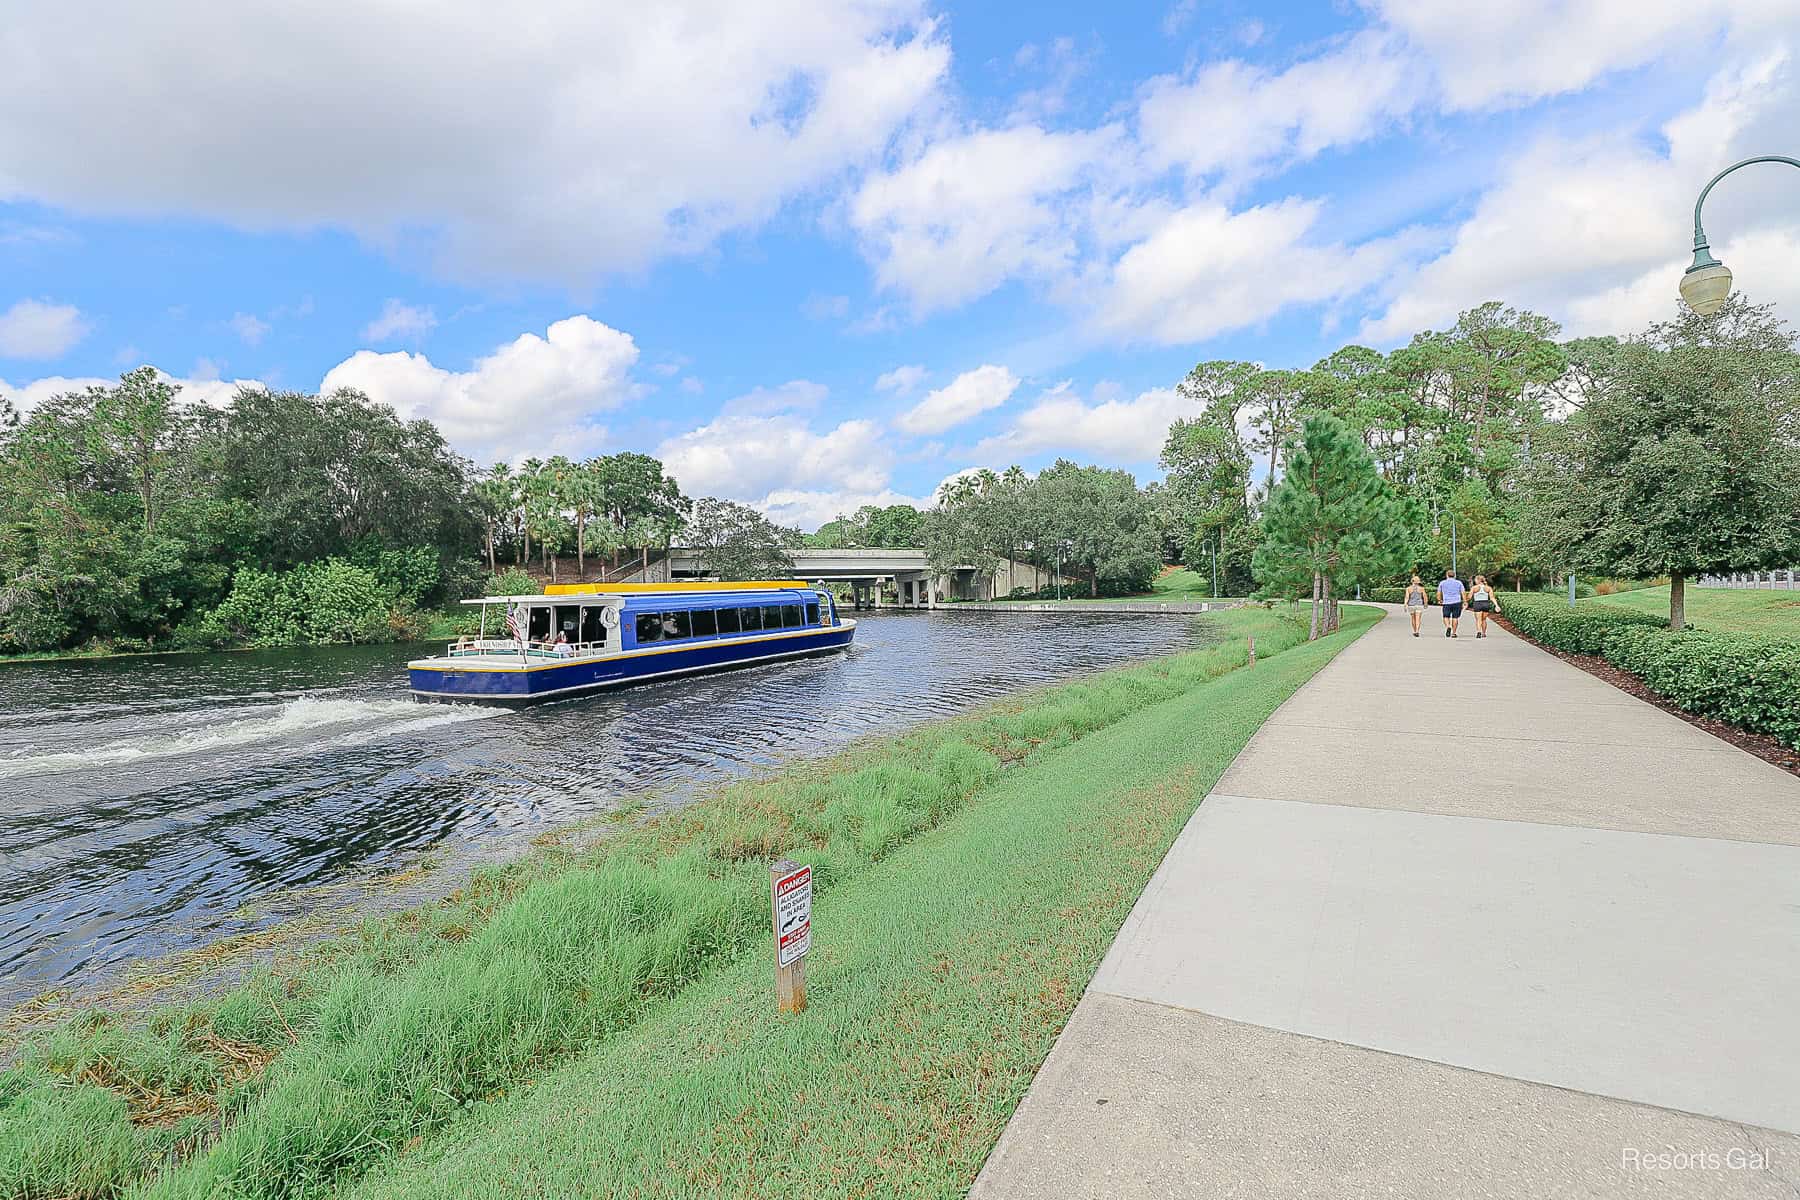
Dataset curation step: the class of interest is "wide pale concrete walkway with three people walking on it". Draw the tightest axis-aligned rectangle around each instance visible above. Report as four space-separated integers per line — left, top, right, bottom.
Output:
972 610 1800 1200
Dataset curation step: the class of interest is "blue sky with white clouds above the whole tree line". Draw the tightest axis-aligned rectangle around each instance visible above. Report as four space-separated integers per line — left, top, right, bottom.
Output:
0 0 1800 527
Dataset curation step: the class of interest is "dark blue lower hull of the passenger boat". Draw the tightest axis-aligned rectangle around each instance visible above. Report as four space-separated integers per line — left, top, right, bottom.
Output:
407 622 857 703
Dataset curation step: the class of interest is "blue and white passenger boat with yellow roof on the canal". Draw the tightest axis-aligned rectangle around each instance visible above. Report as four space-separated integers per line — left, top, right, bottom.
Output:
407 579 857 703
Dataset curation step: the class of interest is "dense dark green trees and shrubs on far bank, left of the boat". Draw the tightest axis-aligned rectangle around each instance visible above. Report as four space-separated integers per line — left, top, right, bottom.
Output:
0 376 477 651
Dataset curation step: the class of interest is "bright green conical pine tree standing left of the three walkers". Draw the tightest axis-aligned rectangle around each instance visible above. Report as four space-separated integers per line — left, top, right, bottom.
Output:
1255 414 1411 640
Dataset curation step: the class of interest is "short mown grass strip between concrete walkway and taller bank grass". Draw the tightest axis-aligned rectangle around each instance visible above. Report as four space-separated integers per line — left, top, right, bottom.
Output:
349 608 1373 1200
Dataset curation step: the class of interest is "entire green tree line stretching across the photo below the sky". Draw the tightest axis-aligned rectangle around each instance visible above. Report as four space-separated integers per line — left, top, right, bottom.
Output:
0 297 1800 653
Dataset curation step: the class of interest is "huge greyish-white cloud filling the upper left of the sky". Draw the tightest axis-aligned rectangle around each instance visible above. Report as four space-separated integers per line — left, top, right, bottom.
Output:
0 0 950 282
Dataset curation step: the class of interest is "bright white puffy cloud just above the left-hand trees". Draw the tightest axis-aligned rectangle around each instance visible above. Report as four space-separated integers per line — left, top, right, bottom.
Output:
319 315 637 461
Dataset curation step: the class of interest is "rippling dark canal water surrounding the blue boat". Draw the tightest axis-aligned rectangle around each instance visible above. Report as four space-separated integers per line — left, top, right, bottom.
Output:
0 612 1208 1013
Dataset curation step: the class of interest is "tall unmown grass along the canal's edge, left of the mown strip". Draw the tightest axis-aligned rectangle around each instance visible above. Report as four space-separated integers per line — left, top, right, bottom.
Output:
0 610 1375 1196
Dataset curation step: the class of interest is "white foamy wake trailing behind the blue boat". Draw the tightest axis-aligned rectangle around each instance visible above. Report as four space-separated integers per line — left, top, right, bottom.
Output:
0 696 500 779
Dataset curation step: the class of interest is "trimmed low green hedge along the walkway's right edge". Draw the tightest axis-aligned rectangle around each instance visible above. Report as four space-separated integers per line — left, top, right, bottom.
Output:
1501 596 1800 748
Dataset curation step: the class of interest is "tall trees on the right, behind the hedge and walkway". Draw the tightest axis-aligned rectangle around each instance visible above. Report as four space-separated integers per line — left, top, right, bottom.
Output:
1150 299 1800 626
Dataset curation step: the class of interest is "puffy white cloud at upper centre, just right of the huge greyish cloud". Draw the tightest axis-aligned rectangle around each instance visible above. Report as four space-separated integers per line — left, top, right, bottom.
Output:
850 124 1120 315
